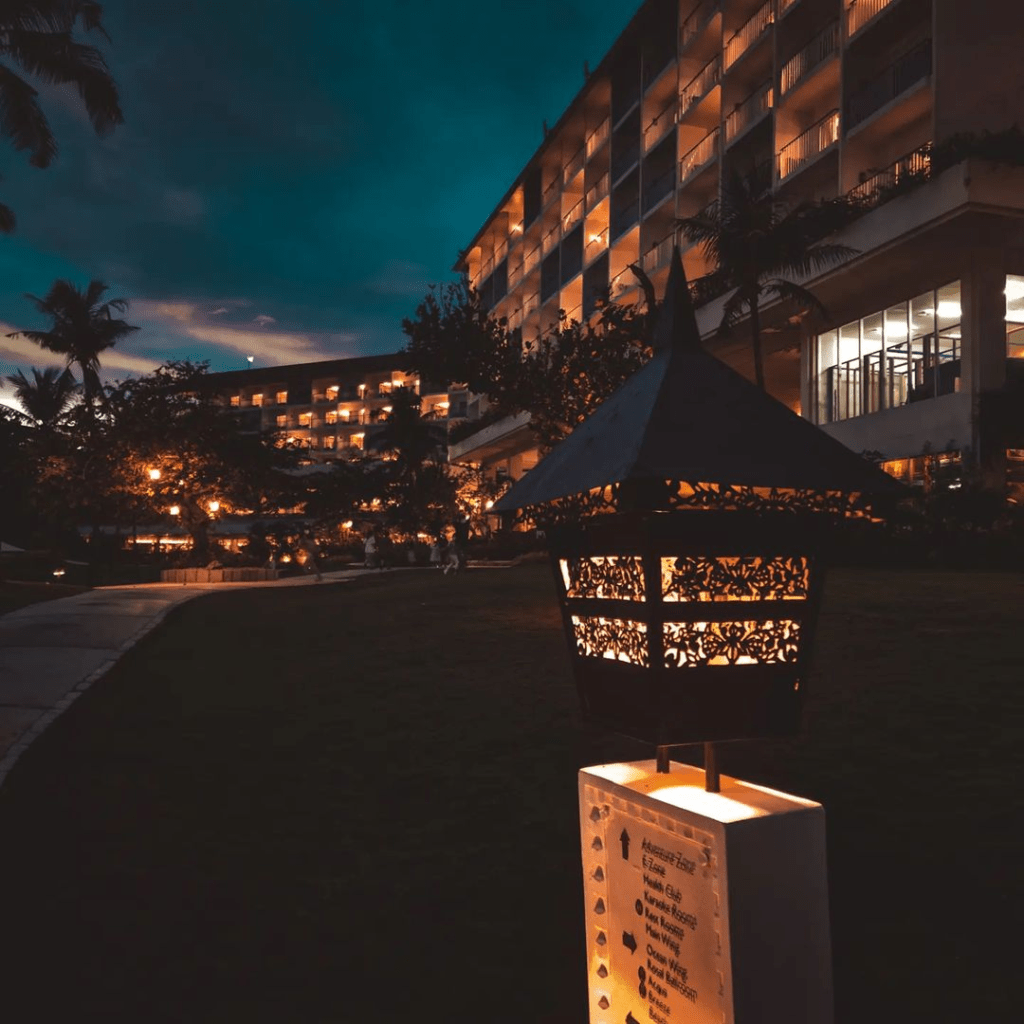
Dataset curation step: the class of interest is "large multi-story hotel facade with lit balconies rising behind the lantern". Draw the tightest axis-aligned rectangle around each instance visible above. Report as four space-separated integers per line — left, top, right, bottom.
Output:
452 0 1024 491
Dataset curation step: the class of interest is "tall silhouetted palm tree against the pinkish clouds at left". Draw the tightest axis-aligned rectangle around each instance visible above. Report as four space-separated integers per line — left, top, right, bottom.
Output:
7 280 138 411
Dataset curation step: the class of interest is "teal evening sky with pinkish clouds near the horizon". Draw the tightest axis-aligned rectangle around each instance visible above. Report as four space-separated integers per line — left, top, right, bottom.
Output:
0 0 639 400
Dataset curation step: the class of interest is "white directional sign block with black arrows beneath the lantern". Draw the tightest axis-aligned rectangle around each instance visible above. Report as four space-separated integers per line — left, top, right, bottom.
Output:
580 761 833 1024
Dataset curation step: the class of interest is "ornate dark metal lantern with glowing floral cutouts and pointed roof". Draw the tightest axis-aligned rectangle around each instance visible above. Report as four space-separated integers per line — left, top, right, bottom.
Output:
496 252 902 766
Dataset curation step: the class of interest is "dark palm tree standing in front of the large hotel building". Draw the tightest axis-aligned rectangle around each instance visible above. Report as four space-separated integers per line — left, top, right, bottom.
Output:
679 171 857 390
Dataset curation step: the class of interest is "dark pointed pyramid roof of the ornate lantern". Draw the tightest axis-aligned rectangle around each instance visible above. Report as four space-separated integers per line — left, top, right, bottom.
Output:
495 248 904 511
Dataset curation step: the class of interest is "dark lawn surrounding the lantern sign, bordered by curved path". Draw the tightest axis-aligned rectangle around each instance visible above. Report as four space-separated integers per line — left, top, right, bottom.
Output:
0 566 1024 1024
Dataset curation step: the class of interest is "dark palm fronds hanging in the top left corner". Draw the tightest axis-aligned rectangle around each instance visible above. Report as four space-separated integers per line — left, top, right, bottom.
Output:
0 0 124 231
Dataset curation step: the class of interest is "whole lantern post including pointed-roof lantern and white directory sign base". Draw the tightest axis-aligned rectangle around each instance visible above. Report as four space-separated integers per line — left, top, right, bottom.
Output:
495 250 902 1024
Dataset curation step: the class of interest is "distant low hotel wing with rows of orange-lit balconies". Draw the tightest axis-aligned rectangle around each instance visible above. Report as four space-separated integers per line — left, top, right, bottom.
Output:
207 354 450 461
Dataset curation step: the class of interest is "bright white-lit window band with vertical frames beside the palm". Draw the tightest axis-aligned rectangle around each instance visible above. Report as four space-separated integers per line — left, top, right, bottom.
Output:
816 279 958 423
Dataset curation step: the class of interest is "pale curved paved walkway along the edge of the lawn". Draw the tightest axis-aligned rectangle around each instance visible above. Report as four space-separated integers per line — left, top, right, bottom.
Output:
0 569 376 785
